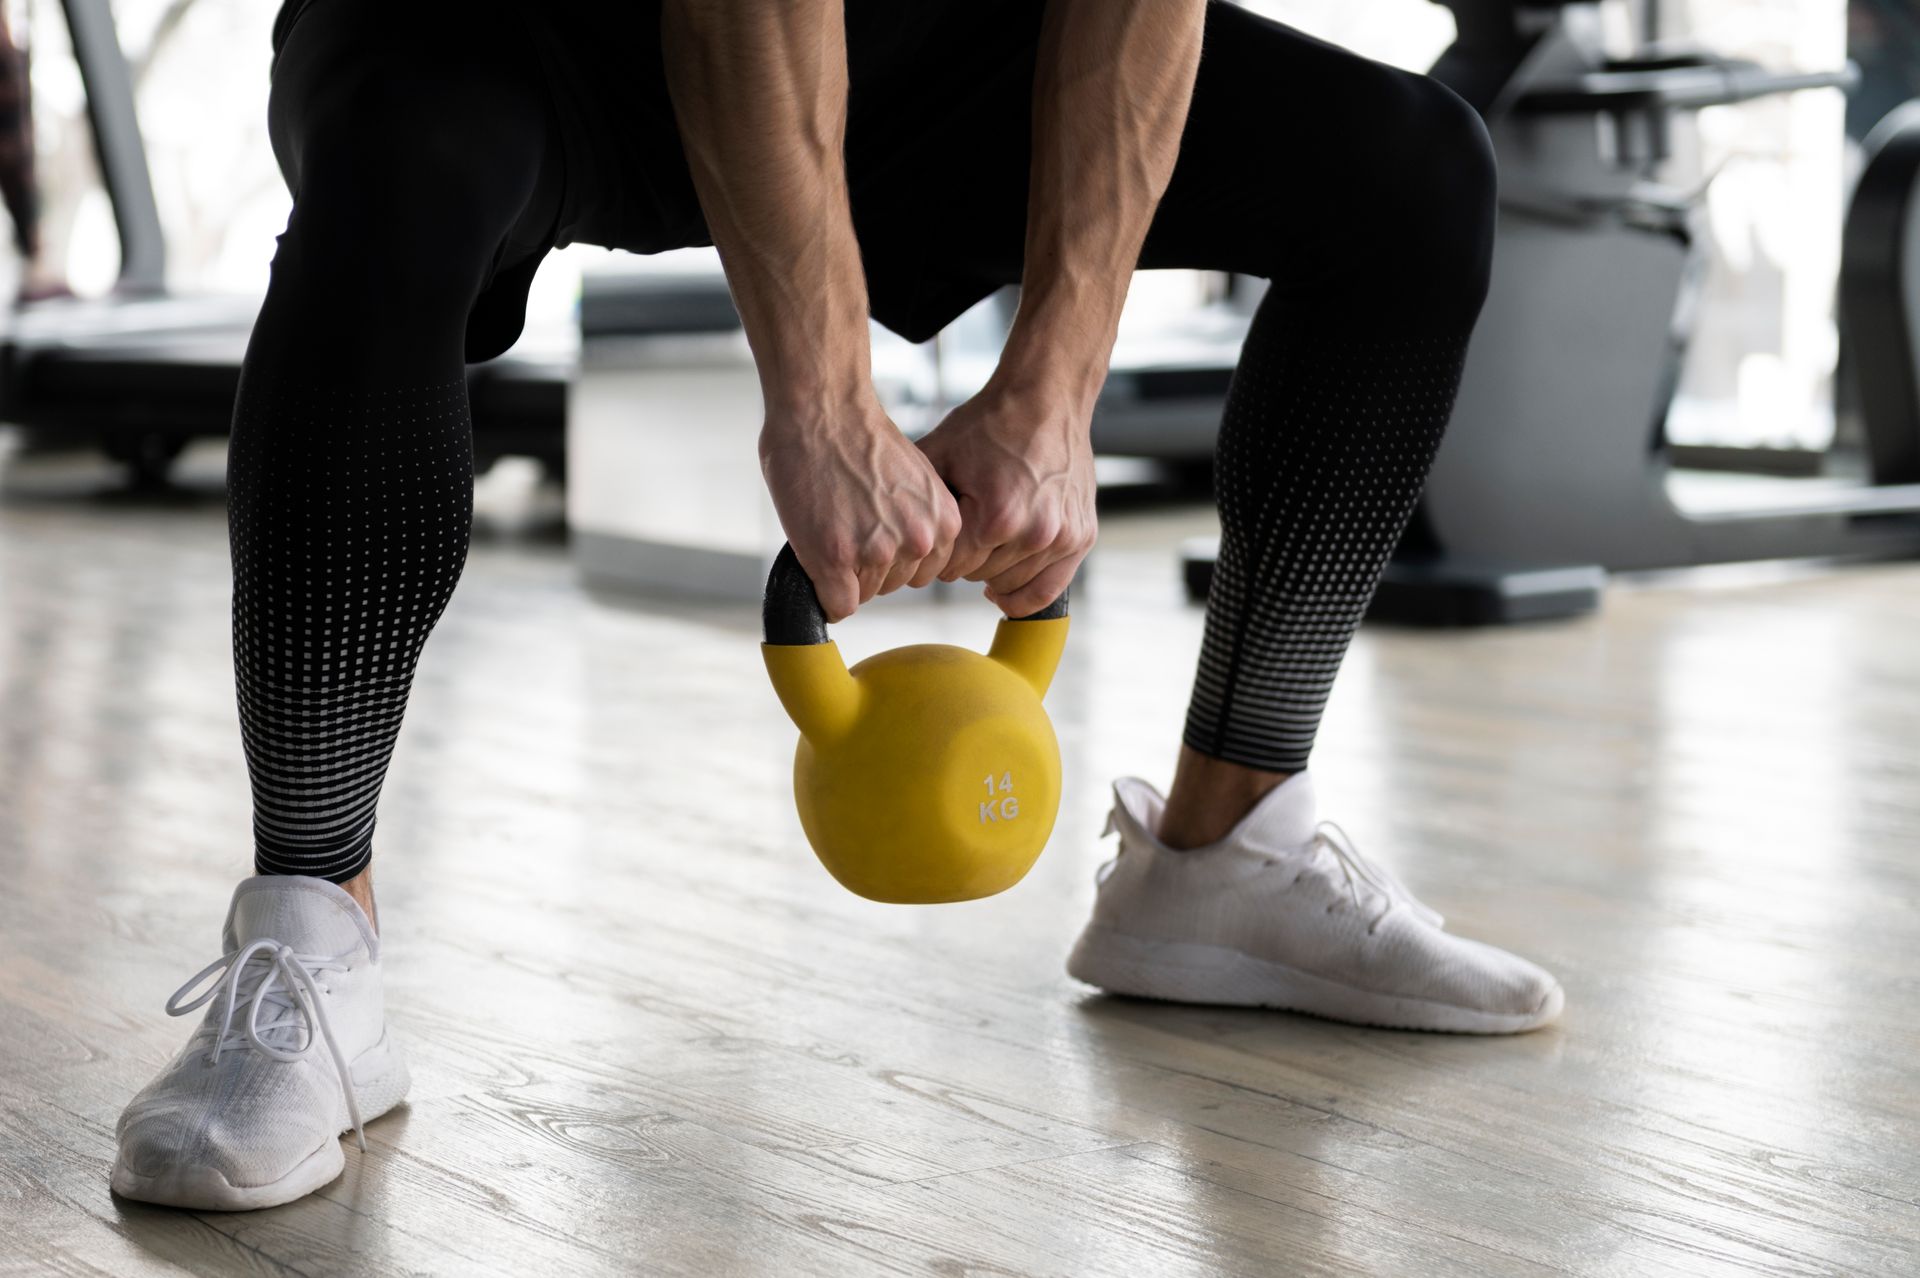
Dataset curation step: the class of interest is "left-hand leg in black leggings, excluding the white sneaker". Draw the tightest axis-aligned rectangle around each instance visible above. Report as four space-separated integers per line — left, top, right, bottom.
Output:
227 0 557 904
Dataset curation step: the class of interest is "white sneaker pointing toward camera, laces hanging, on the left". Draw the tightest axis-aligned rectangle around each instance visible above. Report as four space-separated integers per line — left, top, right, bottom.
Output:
113 875 407 1211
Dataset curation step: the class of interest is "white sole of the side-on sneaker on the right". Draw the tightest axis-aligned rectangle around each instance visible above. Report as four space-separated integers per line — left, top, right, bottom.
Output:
1068 927 1567 1034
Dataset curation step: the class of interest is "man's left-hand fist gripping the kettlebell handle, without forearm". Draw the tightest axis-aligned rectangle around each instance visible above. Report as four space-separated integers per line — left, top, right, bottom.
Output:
760 395 960 622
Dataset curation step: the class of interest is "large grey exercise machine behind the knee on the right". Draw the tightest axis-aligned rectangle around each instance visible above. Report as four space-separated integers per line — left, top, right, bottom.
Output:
1187 0 1920 624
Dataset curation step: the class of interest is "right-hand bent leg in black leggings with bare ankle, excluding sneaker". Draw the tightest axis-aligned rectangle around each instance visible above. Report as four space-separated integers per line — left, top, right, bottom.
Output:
1142 19 1494 846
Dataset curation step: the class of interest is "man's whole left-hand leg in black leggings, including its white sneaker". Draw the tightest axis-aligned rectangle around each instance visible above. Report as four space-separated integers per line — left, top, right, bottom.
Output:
113 0 557 1209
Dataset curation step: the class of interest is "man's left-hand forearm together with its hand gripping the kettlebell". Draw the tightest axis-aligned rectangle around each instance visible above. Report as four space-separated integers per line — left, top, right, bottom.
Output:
660 0 960 622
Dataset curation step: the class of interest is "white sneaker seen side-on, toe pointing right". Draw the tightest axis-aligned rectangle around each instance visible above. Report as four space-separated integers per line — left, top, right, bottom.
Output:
1068 773 1565 1034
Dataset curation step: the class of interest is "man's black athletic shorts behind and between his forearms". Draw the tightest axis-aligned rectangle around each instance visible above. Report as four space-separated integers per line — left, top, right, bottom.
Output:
273 0 1044 357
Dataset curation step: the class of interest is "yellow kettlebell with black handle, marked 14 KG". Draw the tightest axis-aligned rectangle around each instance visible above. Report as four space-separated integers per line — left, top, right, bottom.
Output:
760 547 1068 906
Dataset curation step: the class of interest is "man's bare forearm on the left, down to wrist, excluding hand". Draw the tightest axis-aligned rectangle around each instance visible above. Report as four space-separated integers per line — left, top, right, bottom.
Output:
660 0 872 420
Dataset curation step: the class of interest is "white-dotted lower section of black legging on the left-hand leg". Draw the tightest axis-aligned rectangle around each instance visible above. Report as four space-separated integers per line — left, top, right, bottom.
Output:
227 378 474 883
